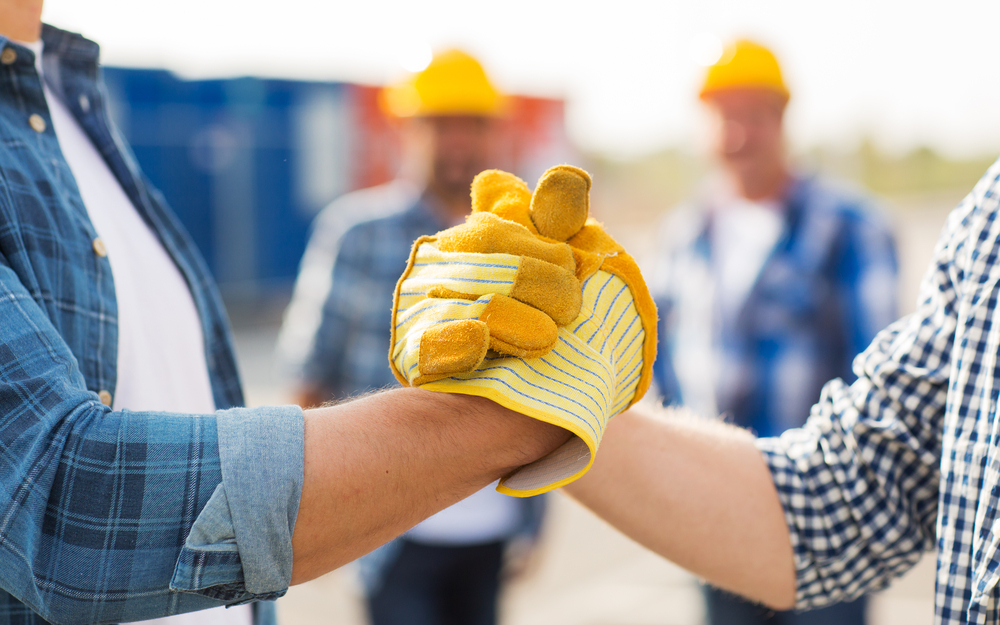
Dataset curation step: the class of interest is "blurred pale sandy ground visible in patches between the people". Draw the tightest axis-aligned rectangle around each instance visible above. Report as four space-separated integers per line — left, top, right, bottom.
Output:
232 176 971 625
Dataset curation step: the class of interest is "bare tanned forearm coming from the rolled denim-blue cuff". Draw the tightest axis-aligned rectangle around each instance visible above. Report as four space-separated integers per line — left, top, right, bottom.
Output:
292 389 569 584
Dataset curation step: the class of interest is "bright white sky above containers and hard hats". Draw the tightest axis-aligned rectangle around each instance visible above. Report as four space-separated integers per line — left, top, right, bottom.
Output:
44 0 1000 156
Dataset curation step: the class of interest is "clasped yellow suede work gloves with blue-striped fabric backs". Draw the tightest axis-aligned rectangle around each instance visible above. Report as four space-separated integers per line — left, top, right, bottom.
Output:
389 165 656 496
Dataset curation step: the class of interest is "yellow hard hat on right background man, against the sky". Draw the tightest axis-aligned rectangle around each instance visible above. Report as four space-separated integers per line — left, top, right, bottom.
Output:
698 39 789 100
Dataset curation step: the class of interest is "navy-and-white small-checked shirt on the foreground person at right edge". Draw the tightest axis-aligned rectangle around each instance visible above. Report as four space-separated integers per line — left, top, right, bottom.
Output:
758 155 1000 624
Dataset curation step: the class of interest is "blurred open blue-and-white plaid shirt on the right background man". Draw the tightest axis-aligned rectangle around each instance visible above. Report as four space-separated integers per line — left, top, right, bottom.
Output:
650 177 897 436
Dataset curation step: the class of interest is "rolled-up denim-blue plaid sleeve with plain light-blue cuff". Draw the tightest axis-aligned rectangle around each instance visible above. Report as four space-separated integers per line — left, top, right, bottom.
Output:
0 251 304 624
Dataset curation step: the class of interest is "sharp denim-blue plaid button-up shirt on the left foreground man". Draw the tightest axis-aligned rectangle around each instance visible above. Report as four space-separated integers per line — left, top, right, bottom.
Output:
0 26 303 624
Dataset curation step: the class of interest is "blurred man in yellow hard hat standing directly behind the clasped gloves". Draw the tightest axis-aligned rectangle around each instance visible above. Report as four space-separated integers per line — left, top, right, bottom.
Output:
281 50 544 625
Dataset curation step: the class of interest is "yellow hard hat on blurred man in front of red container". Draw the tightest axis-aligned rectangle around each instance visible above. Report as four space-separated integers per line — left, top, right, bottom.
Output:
379 50 503 117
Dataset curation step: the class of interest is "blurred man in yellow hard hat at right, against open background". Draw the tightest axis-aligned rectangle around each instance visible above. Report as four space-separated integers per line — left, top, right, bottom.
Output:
650 41 897 625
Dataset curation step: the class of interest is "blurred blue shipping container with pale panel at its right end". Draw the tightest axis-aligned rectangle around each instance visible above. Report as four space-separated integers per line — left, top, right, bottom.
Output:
104 68 350 295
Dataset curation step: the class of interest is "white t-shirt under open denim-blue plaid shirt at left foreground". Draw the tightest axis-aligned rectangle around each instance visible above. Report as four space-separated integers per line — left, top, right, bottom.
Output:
21 41 253 625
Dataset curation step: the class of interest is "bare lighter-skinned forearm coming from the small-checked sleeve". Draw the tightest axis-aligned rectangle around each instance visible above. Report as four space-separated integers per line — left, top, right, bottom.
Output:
566 409 795 609
